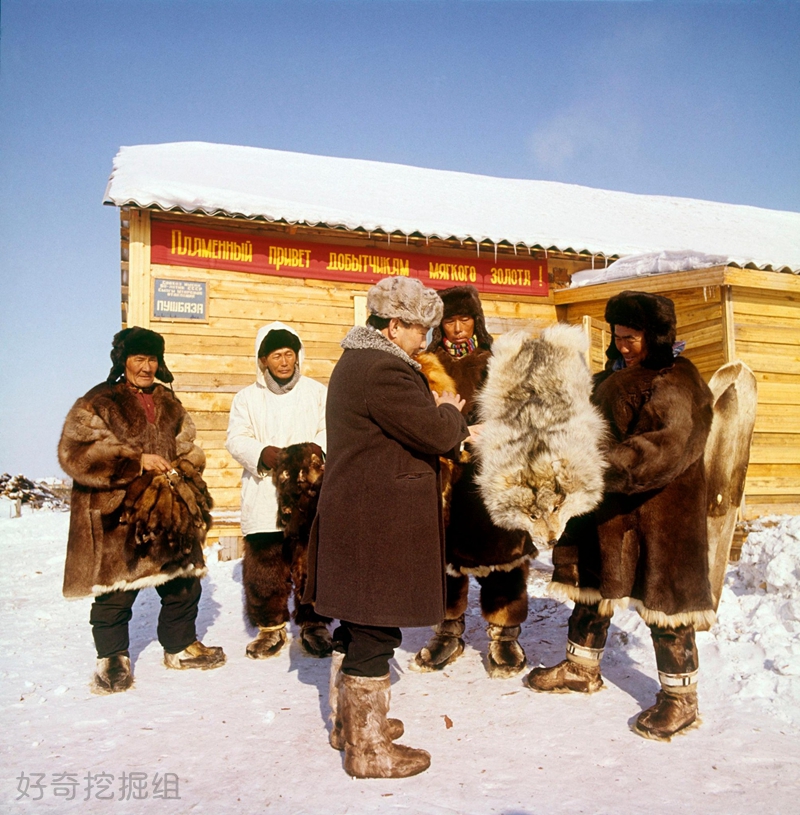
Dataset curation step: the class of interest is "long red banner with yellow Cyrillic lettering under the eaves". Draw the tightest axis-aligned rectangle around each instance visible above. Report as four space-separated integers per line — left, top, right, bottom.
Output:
151 219 548 297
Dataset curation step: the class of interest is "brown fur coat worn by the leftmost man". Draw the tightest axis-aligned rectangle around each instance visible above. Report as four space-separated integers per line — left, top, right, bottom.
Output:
58 382 206 597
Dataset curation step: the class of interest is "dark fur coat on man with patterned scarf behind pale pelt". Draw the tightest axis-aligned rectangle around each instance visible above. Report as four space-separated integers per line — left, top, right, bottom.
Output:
434 346 536 576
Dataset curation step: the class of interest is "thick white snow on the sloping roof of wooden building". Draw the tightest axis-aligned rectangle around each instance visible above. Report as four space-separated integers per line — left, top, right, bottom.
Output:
104 142 800 272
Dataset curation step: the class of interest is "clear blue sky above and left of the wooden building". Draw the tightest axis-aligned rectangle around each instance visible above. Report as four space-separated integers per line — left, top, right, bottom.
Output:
0 0 800 477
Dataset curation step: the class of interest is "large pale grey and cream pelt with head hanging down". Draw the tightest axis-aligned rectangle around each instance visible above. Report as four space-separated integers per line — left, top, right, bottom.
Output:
477 324 606 546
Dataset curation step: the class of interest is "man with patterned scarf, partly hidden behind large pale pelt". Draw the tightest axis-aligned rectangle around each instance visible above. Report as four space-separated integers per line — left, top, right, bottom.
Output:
415 286 536 678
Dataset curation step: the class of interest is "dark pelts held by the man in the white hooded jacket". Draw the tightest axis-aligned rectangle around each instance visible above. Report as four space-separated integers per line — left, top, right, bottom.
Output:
272 443 325 542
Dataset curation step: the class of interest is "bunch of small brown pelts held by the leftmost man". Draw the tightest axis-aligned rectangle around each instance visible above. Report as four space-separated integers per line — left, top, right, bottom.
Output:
120 460 213 551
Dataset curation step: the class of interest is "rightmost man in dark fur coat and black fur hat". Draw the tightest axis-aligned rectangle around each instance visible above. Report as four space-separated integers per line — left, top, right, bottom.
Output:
526 291 714 740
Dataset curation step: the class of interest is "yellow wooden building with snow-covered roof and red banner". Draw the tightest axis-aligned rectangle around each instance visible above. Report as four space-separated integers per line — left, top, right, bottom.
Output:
105 143 800 557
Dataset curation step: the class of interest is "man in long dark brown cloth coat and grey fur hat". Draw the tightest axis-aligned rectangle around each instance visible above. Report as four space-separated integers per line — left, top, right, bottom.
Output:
306 277 470 778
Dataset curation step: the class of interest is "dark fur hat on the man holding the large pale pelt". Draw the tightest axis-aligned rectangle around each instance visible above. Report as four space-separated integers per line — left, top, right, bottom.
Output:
606 291 677 370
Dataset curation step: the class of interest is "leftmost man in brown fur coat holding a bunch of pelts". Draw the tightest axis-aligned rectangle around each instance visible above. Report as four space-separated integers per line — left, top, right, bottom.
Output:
58 327 225 693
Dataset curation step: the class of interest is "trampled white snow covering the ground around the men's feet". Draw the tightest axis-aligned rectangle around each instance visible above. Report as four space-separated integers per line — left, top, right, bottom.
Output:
0 502 800 815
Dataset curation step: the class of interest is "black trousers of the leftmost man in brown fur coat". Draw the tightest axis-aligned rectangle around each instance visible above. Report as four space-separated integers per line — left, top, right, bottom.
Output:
89 577 202 657
